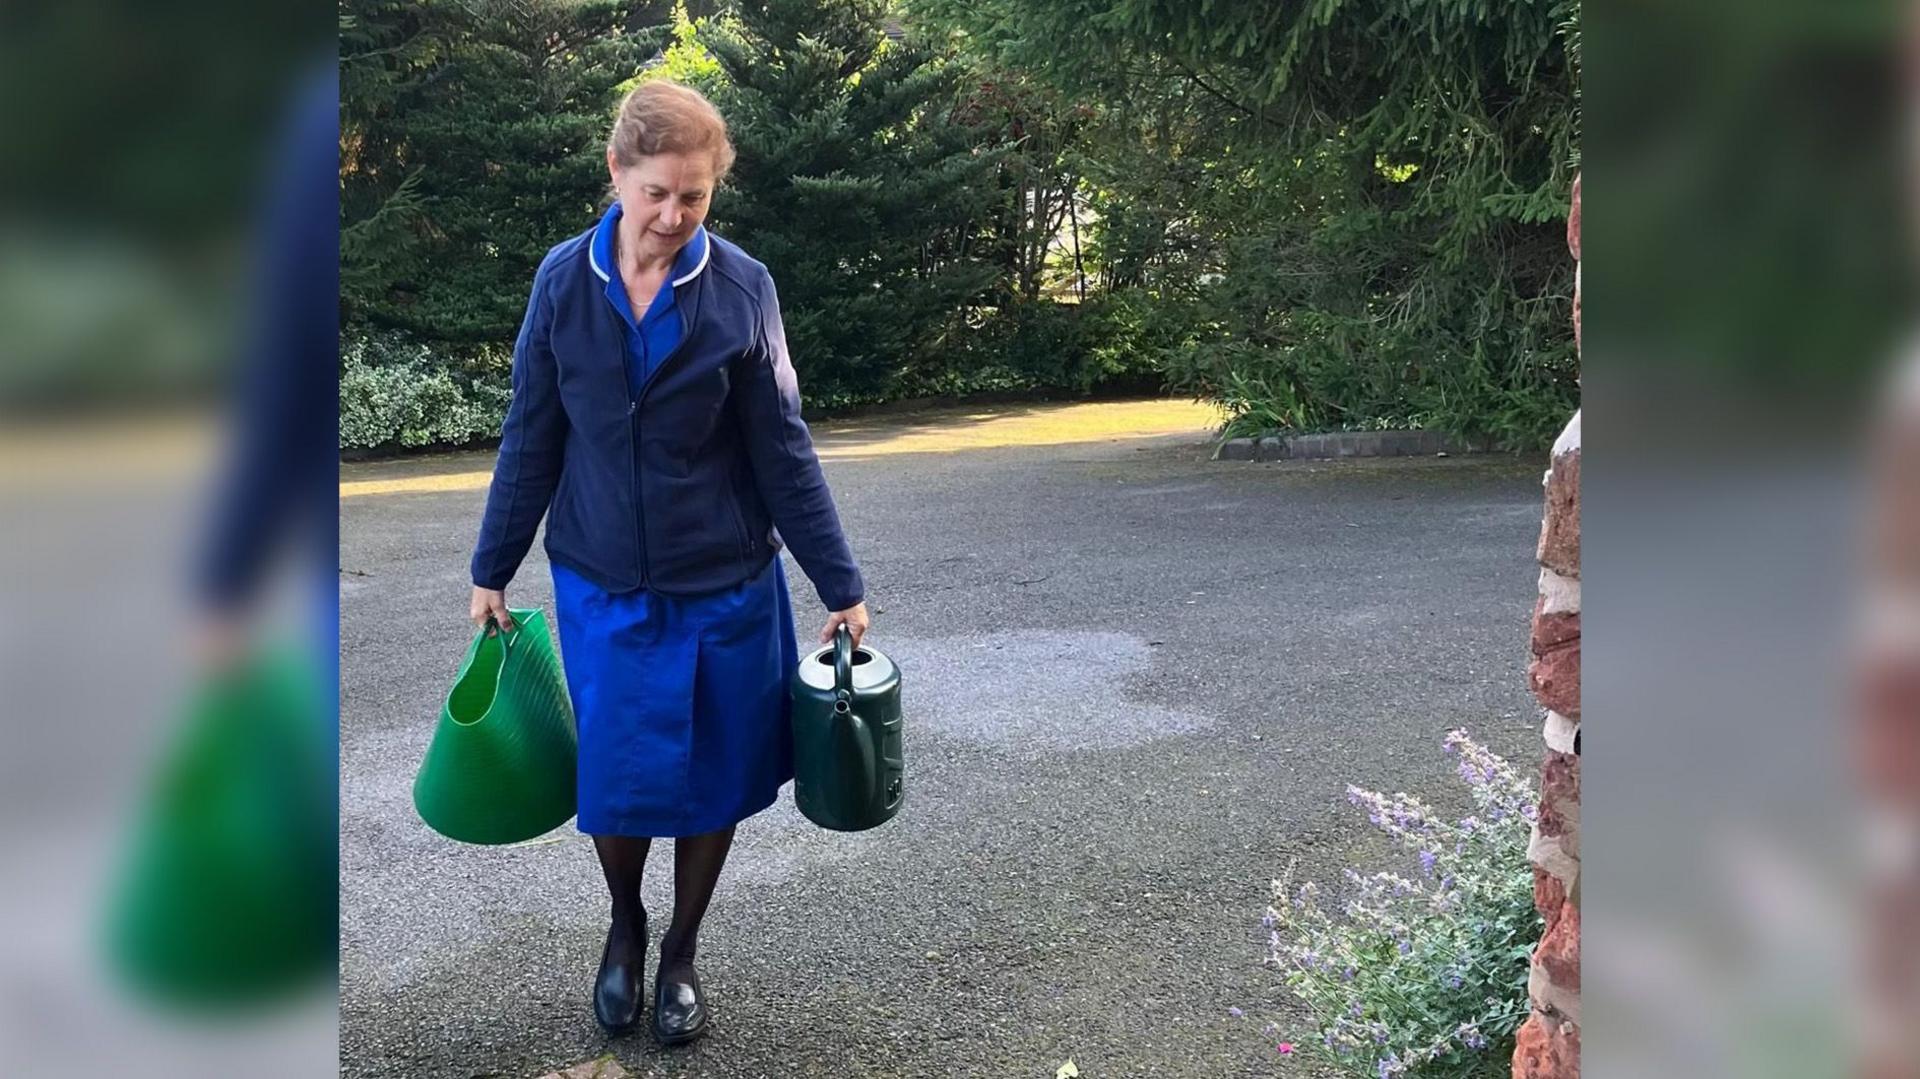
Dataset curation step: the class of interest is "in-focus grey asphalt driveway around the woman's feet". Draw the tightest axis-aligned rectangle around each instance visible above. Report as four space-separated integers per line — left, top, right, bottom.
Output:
340 407 1544 1079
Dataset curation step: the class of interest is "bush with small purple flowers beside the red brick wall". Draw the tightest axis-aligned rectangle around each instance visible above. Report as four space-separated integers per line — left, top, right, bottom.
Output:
1265 730 1542 1079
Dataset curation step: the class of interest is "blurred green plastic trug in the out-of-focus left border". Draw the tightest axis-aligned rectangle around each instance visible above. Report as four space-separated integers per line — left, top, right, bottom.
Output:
104 633 340 1008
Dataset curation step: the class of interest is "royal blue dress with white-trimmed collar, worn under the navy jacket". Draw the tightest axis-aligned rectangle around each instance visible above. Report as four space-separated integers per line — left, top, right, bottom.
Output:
551 204 801 837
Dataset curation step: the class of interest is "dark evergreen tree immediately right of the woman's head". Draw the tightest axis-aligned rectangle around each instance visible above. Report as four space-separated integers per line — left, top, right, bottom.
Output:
699 0 996 405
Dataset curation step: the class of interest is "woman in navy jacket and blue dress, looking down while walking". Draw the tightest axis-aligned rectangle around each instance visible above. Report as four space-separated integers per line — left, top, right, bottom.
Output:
470 81 868 1044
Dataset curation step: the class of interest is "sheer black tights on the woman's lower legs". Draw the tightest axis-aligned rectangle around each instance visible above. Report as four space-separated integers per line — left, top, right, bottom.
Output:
593 827 733 979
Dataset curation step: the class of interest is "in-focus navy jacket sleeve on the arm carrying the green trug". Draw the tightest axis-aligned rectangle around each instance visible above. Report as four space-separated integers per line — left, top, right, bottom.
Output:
472 255 566 587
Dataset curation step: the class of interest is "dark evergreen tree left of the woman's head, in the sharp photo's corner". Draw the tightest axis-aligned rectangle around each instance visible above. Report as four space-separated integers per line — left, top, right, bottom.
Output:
340 0 670 342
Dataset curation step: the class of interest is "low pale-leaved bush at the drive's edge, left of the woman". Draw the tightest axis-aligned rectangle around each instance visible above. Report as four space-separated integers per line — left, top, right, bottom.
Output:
340 328 513 449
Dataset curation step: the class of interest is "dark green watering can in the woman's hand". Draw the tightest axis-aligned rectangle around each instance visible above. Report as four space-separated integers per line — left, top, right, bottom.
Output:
793 626 906 831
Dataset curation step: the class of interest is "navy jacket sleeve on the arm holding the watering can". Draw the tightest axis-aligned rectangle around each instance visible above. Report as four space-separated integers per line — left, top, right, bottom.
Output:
732 278 866 611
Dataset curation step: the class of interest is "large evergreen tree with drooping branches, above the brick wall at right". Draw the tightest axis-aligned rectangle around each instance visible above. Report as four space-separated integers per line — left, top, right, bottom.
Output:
910 0 1580 447
